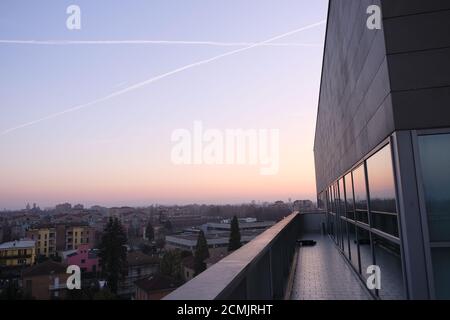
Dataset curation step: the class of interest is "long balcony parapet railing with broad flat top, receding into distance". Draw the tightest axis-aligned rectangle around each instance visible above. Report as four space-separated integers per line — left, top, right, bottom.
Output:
164 212 300 300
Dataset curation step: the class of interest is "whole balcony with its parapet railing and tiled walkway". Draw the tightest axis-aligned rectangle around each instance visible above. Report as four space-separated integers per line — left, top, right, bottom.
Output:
164 211 372 300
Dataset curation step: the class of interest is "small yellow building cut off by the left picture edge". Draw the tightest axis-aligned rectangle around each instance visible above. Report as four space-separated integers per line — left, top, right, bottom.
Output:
0 240 36 267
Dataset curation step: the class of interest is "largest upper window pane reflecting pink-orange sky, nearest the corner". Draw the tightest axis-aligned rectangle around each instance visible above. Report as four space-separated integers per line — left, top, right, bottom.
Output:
367 145 399 237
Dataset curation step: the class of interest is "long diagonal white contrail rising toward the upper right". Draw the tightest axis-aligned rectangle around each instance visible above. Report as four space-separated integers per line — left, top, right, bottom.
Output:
0 20 326 136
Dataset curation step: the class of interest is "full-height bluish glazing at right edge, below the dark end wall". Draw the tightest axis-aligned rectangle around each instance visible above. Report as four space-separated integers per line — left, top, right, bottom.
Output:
418 134 450 299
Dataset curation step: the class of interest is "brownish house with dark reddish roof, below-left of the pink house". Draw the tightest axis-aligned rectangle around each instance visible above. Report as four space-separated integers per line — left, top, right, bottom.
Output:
22 260 70 300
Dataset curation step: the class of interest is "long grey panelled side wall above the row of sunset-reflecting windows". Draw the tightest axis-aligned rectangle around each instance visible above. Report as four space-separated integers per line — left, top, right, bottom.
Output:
314 0 394 191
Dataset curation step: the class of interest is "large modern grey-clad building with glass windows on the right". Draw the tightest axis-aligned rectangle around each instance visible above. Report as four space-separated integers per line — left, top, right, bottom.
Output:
314 0 450 299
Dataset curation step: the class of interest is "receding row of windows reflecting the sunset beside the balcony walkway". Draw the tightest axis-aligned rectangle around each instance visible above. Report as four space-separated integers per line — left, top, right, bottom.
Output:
327 144 406 299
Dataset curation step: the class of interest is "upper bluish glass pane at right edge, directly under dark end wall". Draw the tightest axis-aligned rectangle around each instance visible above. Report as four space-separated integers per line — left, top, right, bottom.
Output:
419 134 450 241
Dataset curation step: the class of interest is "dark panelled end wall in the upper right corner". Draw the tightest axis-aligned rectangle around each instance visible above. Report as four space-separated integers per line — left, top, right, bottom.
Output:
382 0 450 130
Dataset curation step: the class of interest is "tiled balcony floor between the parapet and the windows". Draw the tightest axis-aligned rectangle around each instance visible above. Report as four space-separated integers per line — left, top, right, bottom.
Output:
291 234 372 300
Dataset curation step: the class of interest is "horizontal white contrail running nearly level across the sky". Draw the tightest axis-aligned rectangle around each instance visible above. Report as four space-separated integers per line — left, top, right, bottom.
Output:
0 40 321 47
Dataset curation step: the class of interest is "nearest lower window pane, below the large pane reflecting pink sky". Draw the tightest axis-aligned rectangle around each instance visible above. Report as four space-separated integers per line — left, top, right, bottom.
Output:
372 233 405 300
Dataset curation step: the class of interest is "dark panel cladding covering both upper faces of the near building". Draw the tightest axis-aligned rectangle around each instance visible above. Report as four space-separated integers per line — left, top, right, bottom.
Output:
314 0 450 192
